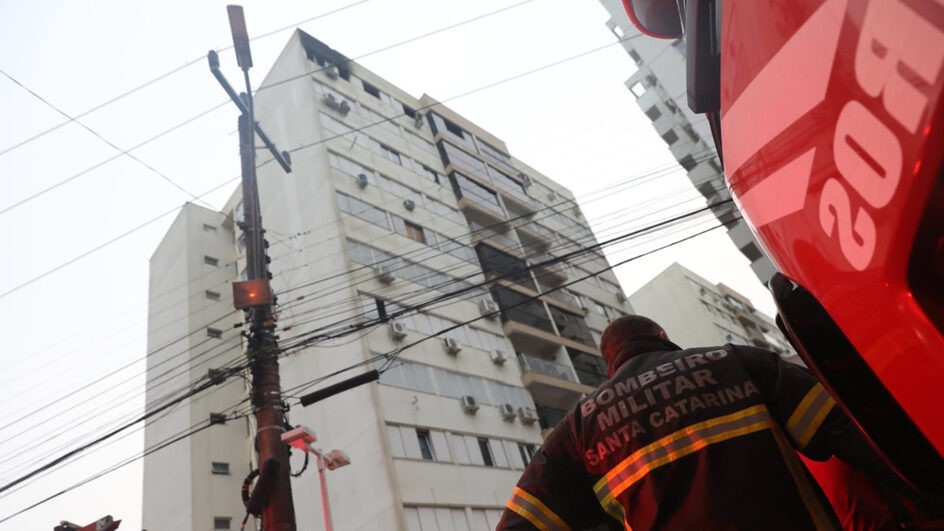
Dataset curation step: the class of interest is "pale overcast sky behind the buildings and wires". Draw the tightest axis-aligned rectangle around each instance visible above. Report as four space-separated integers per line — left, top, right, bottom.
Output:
0 0 772 529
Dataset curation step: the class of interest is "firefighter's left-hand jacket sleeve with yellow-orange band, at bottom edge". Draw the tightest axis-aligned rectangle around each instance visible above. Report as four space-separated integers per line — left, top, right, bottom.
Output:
496 415 612 531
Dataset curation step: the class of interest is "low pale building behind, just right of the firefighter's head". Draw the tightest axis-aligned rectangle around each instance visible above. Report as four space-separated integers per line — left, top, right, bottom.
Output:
629 263 798 362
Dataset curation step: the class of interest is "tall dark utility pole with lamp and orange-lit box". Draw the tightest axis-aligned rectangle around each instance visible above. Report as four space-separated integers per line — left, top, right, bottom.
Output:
207 5 296 531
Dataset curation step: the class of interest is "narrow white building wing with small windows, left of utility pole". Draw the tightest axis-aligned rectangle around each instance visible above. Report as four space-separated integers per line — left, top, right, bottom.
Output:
143 204 249 530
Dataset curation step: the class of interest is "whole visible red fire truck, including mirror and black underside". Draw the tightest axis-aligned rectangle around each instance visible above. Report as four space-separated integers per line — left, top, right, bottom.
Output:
624 0 944 494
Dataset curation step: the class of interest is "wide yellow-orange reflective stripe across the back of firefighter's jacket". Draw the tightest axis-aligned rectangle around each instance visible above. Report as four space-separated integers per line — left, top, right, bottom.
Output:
594 404 774 521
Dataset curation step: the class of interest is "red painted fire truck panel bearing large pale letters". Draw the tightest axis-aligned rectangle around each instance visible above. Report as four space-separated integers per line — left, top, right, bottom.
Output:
720 0 944 455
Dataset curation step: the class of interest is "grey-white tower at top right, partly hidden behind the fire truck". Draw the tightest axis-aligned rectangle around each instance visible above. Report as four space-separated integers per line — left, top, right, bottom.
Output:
600 0 775 284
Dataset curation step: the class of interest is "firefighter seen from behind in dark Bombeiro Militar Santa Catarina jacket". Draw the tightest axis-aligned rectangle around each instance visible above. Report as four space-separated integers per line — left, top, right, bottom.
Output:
497 315 884 531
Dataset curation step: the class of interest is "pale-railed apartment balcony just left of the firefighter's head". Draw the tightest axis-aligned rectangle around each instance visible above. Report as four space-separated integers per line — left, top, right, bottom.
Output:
518 353 593 409
